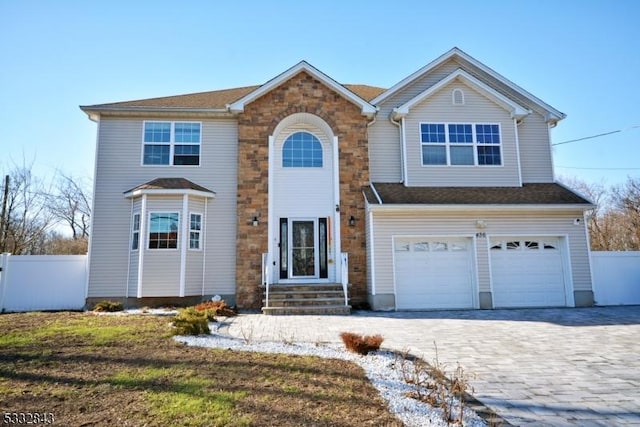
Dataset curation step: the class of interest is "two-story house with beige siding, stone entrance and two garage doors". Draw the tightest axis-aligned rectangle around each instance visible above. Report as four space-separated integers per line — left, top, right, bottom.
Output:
81 48 593 310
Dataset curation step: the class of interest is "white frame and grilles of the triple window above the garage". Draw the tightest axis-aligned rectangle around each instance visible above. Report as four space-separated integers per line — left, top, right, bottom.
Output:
418 121 504 168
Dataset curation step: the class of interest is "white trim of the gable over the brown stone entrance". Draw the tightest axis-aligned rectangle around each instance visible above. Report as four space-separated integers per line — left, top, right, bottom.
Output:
227 61 377 116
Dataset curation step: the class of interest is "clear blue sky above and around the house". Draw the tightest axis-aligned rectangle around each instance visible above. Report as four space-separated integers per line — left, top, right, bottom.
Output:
0 0 640 185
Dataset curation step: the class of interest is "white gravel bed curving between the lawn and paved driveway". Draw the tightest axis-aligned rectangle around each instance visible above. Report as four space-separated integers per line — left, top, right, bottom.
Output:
174 323 487 427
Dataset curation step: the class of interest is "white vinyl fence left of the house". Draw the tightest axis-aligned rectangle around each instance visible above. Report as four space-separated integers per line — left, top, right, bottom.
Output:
0 254 87 312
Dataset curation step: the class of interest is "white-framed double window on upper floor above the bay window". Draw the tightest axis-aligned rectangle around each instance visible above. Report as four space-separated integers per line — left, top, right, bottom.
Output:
142 122 201 166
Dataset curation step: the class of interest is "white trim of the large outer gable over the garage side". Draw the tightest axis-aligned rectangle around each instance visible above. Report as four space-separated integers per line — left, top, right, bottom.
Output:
371 47 566 123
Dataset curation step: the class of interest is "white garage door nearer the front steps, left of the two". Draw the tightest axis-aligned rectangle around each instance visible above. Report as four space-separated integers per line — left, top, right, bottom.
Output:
394 237 474 310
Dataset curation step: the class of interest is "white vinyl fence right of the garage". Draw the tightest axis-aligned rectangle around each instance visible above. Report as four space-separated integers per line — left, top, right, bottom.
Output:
591 252 640 305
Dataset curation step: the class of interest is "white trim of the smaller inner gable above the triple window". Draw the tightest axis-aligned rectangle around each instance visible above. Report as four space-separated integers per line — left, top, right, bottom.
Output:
393 68 531 119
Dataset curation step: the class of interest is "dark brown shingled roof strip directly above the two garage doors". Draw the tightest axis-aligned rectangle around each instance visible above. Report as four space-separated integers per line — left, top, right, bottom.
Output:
364 183 593 209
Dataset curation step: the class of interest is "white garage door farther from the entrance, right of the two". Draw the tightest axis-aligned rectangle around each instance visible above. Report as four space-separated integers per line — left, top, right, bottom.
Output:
490 237 567 308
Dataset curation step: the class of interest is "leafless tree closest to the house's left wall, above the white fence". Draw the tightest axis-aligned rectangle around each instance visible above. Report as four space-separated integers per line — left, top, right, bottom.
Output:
49 171 91 240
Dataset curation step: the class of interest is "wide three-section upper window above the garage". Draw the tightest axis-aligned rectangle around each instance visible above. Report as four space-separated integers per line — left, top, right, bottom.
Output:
420 123 502 166
